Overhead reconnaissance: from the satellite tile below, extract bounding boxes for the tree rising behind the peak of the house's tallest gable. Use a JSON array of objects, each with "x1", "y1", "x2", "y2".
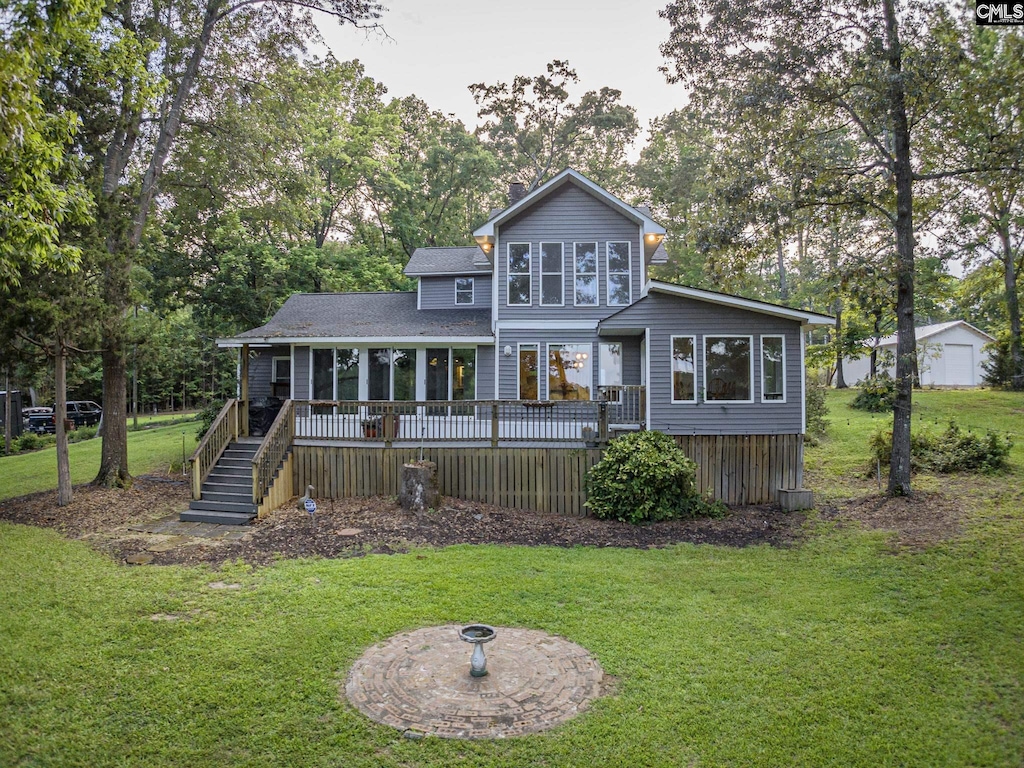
[{"x1": 469, "y1": 59, "x2": 639, "y2": 190}]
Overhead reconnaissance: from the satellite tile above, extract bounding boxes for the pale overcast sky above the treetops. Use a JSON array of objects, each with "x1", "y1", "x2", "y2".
[{"x1": 321, "y1": 0, "x2": 685, "y2": 150}]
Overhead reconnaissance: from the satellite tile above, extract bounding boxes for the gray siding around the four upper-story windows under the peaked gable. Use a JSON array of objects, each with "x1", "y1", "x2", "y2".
[{"x1": 495, "y1": 184, "x2": 643, "y2": 323}]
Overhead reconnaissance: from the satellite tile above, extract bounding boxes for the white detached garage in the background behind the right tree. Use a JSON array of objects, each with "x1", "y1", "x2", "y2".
[{"x1": 843, "y1": 321, "x2": 995, "y2": 387}]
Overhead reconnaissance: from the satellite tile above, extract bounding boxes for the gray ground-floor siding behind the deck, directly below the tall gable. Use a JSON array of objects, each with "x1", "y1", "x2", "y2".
[{"x1": 495, "y1": 329, "x2": 640, "y2": 400}]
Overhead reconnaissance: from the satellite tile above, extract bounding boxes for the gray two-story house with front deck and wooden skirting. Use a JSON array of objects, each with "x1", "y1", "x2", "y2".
[{"x1": 194, "y1": 170, "x2": 833, "y2": 528}]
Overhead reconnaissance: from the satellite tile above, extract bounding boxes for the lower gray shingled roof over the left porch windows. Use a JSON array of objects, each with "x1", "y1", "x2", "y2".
[{"x1": 217, "y1": 291, "x2": 495, "y2": 346}]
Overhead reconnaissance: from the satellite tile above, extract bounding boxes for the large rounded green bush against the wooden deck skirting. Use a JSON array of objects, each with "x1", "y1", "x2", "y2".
[{"x1": 587, "y1": 431, "x2": 724, "y2": 523}]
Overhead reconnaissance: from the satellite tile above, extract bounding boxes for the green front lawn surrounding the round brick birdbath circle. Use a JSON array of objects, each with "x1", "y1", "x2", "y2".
[{"x1": 0, "y1": 392, "x2": 1024, "y2": 768}]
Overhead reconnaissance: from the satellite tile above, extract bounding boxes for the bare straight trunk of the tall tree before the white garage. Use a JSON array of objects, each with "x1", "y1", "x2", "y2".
[{"x1": 883, "y1": 0, "x2": 918, "y2": 496}]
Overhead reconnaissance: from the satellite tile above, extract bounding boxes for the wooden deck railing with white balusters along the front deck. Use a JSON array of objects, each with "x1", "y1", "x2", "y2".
[{"x1": 295, "y1": 387, "x2": 643, "y2": 446}]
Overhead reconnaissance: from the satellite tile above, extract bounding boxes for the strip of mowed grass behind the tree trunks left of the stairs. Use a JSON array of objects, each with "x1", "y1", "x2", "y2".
[{"x1": 0, "y1": 423, "x2": 196, "y2": 500}]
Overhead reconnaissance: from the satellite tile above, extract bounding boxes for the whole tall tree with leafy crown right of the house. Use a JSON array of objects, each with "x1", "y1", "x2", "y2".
[{"x1": 662, "y1": 0, "x2": 948, "y2": 495}]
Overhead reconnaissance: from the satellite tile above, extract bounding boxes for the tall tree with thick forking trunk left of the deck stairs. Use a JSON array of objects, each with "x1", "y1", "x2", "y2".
[{"x1": 57, "y1": 0, "x2": 380, "y2": 485}]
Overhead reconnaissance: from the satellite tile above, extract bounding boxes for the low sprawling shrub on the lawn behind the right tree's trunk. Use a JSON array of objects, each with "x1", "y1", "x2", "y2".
[{"x1": 870, "y1": 422, "x2": 1014, "y2": 474}]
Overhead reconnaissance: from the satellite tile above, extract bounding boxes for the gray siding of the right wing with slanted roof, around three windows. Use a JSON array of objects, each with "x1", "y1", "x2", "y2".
[{"x1": 602, "y1": 293, "x2": 803, "y2": 434}]
